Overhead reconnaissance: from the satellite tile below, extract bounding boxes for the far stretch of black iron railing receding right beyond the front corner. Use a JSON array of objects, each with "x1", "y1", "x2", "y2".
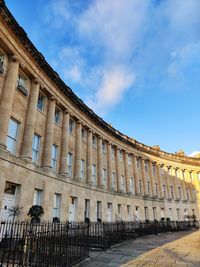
[{"x1": 89, "y1": 221, "x2": 198, "y2": 250}]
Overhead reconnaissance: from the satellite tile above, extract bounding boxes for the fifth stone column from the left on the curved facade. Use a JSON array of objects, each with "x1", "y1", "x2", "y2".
[{"x1": 74, "y1": 121, "x2": 82, "y2": 180}]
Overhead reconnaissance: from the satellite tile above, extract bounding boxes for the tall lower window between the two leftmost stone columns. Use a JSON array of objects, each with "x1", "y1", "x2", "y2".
[{"x1": 6, "y1": 119, "x2": 19, "y2": 154}]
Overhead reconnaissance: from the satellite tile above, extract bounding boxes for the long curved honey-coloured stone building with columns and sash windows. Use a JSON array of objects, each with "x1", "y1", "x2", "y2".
[{"x1": 0, "y1": 1, "x2": 200, "y2": 221}]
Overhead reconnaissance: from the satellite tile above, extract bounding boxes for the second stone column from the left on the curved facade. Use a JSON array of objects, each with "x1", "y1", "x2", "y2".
[{"x1": 21, "y1": 79, "x2": 40, "y2": 160}]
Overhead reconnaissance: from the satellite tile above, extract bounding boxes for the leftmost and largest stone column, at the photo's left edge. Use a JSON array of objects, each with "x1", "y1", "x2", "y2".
[{"x1": 0, "y1": 56, "x2": 19, "y2": 148}]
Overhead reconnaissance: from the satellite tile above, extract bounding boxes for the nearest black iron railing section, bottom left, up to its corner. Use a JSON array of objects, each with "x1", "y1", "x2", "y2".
[{"x1": 0, "y1": 222, "x2": 89, "y2": 267}]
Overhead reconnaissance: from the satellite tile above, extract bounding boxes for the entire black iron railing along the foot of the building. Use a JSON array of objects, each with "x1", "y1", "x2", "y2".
[{"x1": 0, "y1": 221, "x2": 198, "y2": 267}]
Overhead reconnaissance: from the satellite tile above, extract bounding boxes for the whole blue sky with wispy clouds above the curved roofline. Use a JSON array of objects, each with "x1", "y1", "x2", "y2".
[{"x1": 6, "y1": 0, "x2": 200, "y2": 154}]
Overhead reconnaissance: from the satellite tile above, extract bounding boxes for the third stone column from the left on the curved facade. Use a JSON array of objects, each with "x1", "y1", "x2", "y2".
[{"x1": 42, "y1": 96, "x2": 56, "y2": 168}]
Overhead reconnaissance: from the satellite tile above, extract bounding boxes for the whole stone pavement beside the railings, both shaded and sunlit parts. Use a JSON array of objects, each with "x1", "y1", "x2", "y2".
[{"x1": 79, "y1": 231, "x2": 200, "y2": 267}]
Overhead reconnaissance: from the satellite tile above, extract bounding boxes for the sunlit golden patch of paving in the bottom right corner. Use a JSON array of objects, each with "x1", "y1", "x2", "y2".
[{"x1": 123, "y1": 231, "x2": 200, "y2": 267}]
